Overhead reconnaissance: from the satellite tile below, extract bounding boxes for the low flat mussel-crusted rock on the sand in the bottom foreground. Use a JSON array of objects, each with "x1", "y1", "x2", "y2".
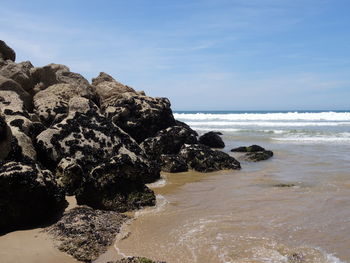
[{"x1": 47, "y1": 206, "x2": 128, "y2": 262}]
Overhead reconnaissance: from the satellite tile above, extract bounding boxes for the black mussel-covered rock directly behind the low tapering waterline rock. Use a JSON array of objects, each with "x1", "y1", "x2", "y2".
[{"x1": 140, "y1": 126, "x2": 197, "y2": 160}]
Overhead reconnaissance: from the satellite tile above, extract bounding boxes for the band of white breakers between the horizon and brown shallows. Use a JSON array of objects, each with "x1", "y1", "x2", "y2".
[{"x1": 174, "y1": 111, "x2": 350, "y2": 143}]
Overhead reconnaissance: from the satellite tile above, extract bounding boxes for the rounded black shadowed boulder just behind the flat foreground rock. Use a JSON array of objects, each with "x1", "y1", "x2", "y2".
[{"x1": 76, "y1": 151, "x2": 159, "y2": 212}]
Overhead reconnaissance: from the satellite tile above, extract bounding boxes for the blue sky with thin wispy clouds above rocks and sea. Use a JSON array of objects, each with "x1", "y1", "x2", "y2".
[{"x1": 0, "y1": 0, "x2": 350, "y2": 110}]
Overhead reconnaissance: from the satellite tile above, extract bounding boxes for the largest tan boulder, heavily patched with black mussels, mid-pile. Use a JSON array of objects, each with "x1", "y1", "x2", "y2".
[{"x1": 36, "y1": 97, "x2": 160, "y2": 194}]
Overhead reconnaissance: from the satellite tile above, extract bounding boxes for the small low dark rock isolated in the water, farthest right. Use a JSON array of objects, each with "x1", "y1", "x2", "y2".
[{"x1": 231, "y1": 144, "x2": 273, "y2": 162}]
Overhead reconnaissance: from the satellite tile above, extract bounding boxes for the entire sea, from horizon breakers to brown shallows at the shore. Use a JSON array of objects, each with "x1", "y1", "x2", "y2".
[{"x1": 97, "y1": 111, "x2": 350, "y2": 263}]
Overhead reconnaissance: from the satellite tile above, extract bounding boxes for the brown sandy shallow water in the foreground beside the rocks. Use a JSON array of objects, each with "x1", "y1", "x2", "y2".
[{"x1": 96, "y1": 143, "x2": 350, "y2": 263}]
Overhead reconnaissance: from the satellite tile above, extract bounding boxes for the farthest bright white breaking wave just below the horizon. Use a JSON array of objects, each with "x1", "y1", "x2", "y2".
[{"x1": 174, "y1": 111, "x2": 350, "y2": 121}]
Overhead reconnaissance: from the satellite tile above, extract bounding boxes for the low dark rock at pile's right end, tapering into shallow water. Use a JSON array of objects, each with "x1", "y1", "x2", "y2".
[{"x1": 180, "y1": 144, "x2": 241, "y2": 172}]
